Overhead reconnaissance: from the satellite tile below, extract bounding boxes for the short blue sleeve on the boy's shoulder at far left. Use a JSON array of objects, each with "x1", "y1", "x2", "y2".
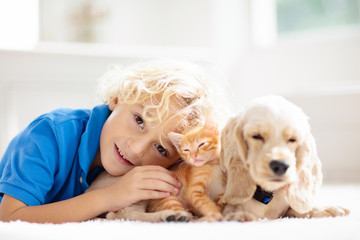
[{"x1": 0, "y1": 118, "x2": 59, "y2": 205}]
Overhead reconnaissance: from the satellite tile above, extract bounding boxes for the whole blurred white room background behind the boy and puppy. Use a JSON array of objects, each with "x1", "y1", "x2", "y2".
[{"x1": 0, "y1": 0, "x2": 360, "y2": 183}]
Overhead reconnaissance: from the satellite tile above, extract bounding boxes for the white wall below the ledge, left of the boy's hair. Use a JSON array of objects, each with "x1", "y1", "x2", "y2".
[{"x1": 0, "y1": 50, "x2": 131, "y2": 155}]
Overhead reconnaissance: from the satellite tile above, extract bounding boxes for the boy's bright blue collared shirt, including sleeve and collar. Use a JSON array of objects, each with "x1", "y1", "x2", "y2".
[{"x1": 0, "y1": 105, "x2": 111, "y2": 206}]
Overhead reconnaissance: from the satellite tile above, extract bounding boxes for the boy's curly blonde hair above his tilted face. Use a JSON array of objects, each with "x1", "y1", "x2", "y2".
[{"x1": 98, "y1": 60, "x2": 217, "y2": 138}]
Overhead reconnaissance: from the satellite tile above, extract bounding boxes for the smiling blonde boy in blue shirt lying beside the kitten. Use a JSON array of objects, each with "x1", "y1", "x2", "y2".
[{"x1": 0, "y1": 61, "x2": 211, "y2": 223}]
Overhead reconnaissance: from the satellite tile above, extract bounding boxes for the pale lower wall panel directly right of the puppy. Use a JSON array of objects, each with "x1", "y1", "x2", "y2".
[{"x1": 289, "y1": 93, "x2": 360, "y2": 182}]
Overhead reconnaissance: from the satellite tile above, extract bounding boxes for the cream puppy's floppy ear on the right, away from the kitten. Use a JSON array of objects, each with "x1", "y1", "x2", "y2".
[{"x1": 288, "y1": 131, "x2": 322, "y2": 213}]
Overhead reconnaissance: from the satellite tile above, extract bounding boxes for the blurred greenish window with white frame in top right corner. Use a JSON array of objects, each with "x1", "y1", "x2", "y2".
[{"x1": 250, "y1": 0, "x2": 360, "y2": 46}]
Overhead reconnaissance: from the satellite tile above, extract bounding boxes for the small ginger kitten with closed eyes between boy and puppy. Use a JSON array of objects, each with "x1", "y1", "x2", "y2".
[{"x1": 147, "y1": 126, "x2": 225, "y2": 221}]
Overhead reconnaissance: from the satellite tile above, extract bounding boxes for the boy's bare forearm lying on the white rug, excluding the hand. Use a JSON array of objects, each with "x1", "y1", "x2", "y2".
[{"x1": 3, "y1": 190, "x2": 108, "y2": 223}]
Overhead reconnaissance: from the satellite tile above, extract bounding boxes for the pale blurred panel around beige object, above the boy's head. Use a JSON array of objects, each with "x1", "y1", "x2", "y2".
[{"x1": 40, "y1": 0, "x2": 213, "y2": 47}]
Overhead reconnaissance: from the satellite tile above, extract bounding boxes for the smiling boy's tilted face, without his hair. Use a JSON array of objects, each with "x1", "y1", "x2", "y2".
[{"x1": 100, "y1": 104, "x2": 180, "y2": 176}]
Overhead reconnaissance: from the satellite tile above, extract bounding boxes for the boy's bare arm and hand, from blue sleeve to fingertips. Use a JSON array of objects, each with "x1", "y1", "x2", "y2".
[{"x1": 0, "y1": 166, "x2": 181, "y2": 223}]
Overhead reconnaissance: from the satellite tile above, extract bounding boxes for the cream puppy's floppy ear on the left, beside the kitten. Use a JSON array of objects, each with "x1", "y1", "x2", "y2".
[{"x1": 220, "y1": 115, "x2": 256, "y2": 205}]
